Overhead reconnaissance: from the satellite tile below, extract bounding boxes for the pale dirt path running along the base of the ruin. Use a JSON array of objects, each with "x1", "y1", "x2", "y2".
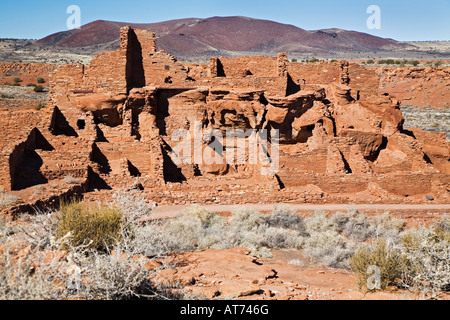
[{"x1": 153, "y1": 204, "x2": 450, "y2": 218}]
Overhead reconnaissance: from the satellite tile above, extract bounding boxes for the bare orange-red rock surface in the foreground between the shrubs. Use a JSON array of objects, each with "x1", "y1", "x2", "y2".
[{"x1": 151, "y1": 248, "x2": 450, "y2": 300}]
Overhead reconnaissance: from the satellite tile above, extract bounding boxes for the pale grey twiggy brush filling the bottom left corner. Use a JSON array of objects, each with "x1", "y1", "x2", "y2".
[{"x1": 0, "y1": 239, "x2": 171, "y2": 300}]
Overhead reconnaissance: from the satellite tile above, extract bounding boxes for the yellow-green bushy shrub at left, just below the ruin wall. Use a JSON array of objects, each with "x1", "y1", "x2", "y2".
[{"x1": 57, "y1": 201, "x2": 124, "y2": 250}]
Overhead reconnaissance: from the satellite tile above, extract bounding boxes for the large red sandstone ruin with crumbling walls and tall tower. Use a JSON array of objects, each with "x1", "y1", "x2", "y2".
[{"x1": 0, "y1": 27, "x2": 450, "y2": 211}]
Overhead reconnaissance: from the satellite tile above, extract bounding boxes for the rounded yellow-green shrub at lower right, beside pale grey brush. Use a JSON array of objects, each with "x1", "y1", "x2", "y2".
[{"x1": 350, "y1": 238, "x2": 407, "y2": 289}]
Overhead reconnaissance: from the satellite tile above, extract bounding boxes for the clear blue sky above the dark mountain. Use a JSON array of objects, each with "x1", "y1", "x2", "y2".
[{"x1": 0, "y1": 0, "x2": 450, "y2": 41}]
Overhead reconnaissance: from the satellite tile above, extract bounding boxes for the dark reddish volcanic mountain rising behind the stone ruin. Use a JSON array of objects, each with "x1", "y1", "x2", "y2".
[{"x1": 37, "y1": 17, "x2": 410, "y2": 58}]
